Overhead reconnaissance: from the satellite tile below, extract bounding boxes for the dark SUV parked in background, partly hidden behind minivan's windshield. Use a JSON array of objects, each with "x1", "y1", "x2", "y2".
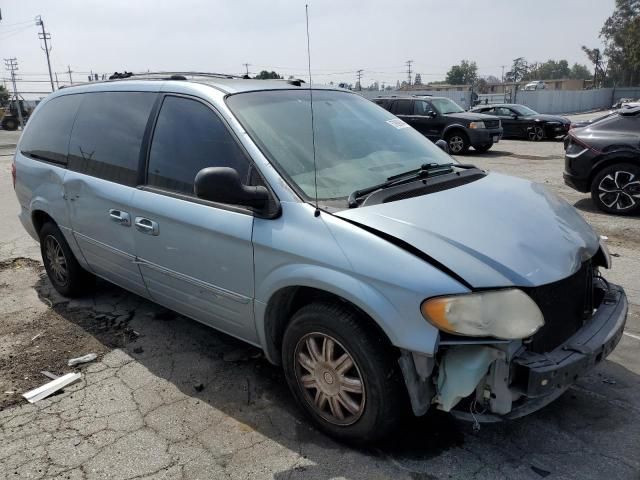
[{"x1": 373, "y1": 97, "x2": 502, "y2": 154}]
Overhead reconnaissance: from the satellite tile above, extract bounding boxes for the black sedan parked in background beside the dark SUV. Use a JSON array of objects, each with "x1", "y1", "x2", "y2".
[{"x1": 471, "y1": 103, "x2": 571, "y2": 142}]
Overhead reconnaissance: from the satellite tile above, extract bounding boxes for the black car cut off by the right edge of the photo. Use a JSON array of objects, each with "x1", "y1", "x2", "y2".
[{"x1": 563, "y1": 107, "x2": 640, "y2": 214}]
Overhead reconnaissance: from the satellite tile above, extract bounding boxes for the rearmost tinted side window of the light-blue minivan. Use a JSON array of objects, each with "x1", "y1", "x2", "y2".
[{"x1": 20, "y1": 95, "x2": 82, "y2": 165}]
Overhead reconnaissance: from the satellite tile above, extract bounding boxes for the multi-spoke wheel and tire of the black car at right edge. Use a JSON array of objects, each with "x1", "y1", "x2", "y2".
[{"x1": 591, "y1": 163, "x2": 640, "y2": 215}]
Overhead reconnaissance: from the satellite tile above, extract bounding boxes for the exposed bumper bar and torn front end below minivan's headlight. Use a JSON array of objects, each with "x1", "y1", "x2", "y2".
[{"x1": 399, "y1": 274, "x2": 628, "y2": 422}]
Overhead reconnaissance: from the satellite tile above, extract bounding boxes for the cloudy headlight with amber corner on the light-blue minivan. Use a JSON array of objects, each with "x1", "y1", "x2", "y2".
[{"x1": 420, "y1": 288, "x2": 544, "y2": 340}]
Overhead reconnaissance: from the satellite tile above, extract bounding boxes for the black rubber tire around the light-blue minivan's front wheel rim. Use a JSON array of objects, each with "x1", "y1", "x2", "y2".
[{"x1": 282, "y1": 308, "x2": 393, "y2": 443}]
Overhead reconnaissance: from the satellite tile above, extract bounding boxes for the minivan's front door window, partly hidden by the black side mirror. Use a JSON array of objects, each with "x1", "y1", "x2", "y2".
[{"x1": 147, "y1": 97, "x2": 249, "y2": 195}]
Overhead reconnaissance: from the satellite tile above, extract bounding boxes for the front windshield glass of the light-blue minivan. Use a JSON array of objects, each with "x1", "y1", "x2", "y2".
[{"x1": 227, "y1": 89, "x2": 453, "y2": 202}]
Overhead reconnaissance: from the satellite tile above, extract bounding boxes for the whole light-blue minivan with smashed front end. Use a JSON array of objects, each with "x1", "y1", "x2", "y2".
[{"x1": 13, "y1": 74, "x2": 627, "y2": 442}]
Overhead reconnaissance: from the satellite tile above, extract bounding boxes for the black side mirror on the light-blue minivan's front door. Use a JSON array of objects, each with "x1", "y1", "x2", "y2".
[{"x1": 194, "y1": 167, "x2": 269, "y2": 208}]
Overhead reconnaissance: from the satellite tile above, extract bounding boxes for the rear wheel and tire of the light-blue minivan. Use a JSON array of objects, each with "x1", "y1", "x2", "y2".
[{"x1": 40, "y1": 222, "x2": 95, "y2": 297}]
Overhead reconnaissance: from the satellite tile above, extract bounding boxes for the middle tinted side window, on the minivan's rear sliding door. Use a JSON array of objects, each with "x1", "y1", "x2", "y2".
[{"x1": 69, "y1": 92, "x2": 156, "y2": 186}]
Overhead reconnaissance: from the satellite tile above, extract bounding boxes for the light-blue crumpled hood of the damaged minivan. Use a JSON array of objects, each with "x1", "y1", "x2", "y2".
[{"x1": 336, "y1": 173, "x2": 599, "y2": 288}]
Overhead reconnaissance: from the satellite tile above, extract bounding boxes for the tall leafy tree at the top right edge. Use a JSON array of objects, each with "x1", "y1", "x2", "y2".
[{"x1": 596, "y1": 0, "x2": 640, "y2": 86}]
